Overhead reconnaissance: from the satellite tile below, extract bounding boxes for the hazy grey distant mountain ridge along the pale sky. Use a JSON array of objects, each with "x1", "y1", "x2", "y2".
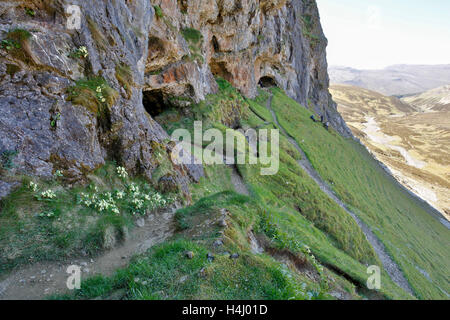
[{"x1": 328, "y1": 64, "x2": 450, "y2": 96}]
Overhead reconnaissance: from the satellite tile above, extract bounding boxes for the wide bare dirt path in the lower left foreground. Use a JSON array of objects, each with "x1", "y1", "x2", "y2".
[{"x1": 0, "y1": 208, "x2": 176, "y2": 300}]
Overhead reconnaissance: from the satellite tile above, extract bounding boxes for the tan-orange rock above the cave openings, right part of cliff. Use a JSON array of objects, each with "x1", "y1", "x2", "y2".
[{"x1": 144, "y1": 0, "x2": 350, "y2": 136}]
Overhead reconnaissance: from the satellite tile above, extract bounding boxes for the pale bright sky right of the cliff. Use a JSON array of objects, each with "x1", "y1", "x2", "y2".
[{"x1": 317, "y1": 0, "x2": 450, "y2": 69}]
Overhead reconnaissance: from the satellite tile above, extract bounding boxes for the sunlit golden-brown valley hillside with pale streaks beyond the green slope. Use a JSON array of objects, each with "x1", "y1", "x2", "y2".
[{"x1": 330, "y1": 85, "x2": 450, "y2": 219}]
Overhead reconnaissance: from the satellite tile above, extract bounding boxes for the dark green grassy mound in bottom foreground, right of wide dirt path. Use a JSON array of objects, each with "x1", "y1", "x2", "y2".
[{"x1": 53, "y1": 192, "x2": 362, "y2": 300}]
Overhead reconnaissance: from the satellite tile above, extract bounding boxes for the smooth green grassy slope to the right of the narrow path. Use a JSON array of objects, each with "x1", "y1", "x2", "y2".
[{"x1": 272, "y1": 89, "x2": 450, "y2": 299}]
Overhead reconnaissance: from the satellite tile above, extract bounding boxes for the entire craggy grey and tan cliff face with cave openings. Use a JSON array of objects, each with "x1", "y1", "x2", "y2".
[{"x1": 0, "y1": 0, "x2": 349, "y2": 199}]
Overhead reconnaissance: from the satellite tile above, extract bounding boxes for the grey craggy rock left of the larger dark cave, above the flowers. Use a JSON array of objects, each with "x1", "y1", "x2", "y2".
[{"x1": 0, "y1": 0, "x2": 202, "y2": 198}]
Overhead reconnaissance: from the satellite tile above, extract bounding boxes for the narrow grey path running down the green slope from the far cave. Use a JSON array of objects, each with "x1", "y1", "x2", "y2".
[{"x1": 267, "y1": 95, "x2": 414, "y2": 295}]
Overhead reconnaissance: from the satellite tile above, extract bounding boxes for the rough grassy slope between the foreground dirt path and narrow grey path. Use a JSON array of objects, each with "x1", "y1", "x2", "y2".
[{"x1": 59, "y1": 82, "x2": 411, "y2": 299}]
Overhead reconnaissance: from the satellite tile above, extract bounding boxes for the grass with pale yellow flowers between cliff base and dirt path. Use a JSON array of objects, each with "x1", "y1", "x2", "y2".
[{"x1": 0, "y1": 164, "x2": 173, "y2": 274}]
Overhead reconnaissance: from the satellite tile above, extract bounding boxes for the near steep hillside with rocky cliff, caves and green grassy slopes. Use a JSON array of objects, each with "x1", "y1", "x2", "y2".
[{"x1": 0, "y1": 0, "x2": 450, "y2": 300}]
